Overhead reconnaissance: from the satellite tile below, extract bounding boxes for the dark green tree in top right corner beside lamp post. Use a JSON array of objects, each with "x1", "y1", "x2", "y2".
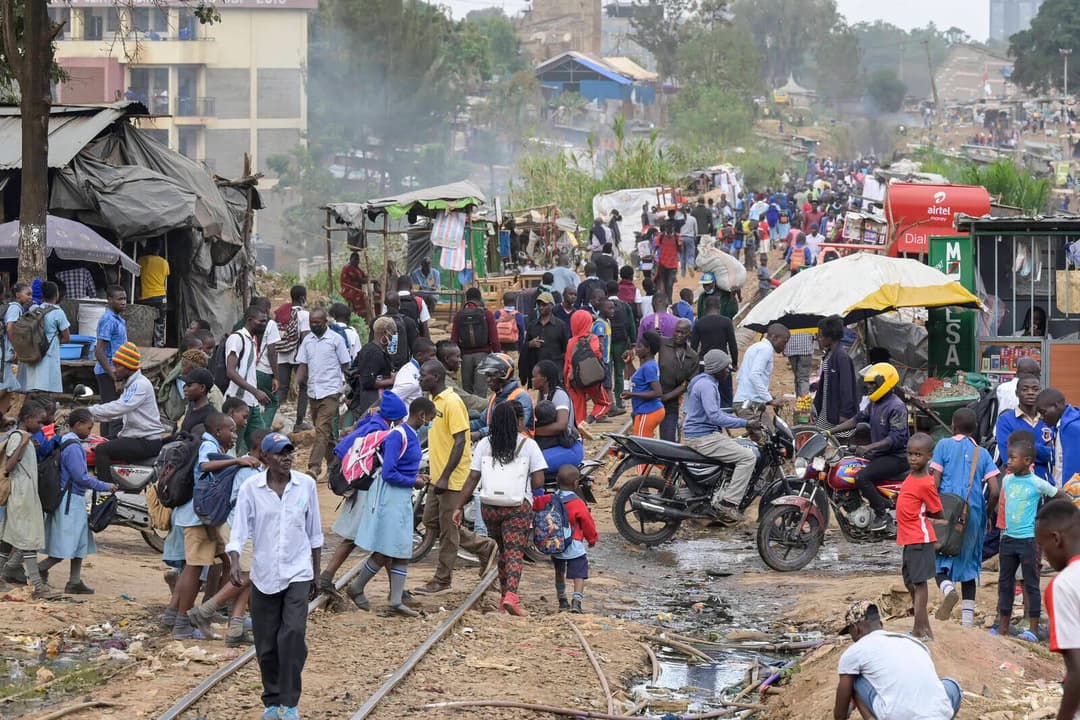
[{"x1": 1009, "y1": 0, "x2": 1080, "y2": 92}]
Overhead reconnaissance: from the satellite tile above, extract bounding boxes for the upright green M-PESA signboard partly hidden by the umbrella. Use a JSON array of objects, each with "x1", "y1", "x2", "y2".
[{"x1": 927, "y1": 235, "x2": 977, "y2": 377}]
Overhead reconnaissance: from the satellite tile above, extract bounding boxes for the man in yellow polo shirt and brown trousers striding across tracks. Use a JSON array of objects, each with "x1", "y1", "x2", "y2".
[{"x1": 414, "y1": 359, "x2": 499, "y2": 595}]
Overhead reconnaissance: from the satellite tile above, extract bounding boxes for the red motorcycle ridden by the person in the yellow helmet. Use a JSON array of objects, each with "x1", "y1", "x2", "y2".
[{"x1": 757, "y1": 433, "x2": 907, "y2": 572}]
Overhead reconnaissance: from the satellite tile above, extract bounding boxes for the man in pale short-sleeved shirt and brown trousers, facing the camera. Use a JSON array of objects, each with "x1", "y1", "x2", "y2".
[{"x1": 296, "y1": 308, "x2": 349, "y2": 477}]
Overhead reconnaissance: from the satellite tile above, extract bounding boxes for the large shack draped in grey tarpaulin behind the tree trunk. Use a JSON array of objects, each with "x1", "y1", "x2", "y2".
[{"x1": 0, "y1": 100, "x2": 261, "y2": 334}]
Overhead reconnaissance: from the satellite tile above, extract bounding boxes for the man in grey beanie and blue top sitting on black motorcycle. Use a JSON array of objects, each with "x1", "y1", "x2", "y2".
[{"x1": 683, "y1": 350, "x2": 761, "y2": 525}]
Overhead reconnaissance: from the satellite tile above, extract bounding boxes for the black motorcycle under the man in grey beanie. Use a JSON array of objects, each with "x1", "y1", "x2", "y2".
[{"x1": 608, "y1": 417, "x2": 795, "y2": 546}]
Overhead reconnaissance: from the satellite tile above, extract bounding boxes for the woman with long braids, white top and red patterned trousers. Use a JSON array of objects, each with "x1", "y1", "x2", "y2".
[{"x1": 454, "y1": 400, "x2": 548, "y2": 615}]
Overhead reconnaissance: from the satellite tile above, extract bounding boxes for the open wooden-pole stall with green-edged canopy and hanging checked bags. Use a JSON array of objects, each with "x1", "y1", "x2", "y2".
[{"x1": 325, "y1": 180, "x2": 487, "y2": 320}]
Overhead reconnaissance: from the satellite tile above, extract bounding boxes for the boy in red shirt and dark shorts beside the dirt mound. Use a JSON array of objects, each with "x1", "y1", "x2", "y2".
[{"x1": 896, "y1": 433, "x2": 942, "y2": 639}]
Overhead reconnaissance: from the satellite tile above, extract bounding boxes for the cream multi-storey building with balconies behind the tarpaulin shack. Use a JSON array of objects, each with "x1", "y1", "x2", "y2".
[{"x1": 49, "y1": 0, "x2": 319, "y2": 248}]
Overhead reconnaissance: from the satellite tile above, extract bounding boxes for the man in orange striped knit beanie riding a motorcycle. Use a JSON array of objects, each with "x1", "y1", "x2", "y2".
[{"x1": 87, "y1": 342, "x2": 164, "y2": 477}]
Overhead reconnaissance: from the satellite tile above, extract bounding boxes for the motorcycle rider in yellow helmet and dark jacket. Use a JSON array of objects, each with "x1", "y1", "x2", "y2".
[{"x1": 832, "y1": 363, "x2": 908, "y2": 532}]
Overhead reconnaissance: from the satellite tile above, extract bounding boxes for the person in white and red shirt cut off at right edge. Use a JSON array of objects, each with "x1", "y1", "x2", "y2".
[{"x1": 1035, "y1": 500, "x2": 1080, "y2": 719}]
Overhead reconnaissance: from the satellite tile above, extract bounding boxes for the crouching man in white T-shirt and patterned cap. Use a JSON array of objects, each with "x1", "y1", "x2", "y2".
[{"x1": 833, "y1": 600, "x2": 962, "y2": 720}]
